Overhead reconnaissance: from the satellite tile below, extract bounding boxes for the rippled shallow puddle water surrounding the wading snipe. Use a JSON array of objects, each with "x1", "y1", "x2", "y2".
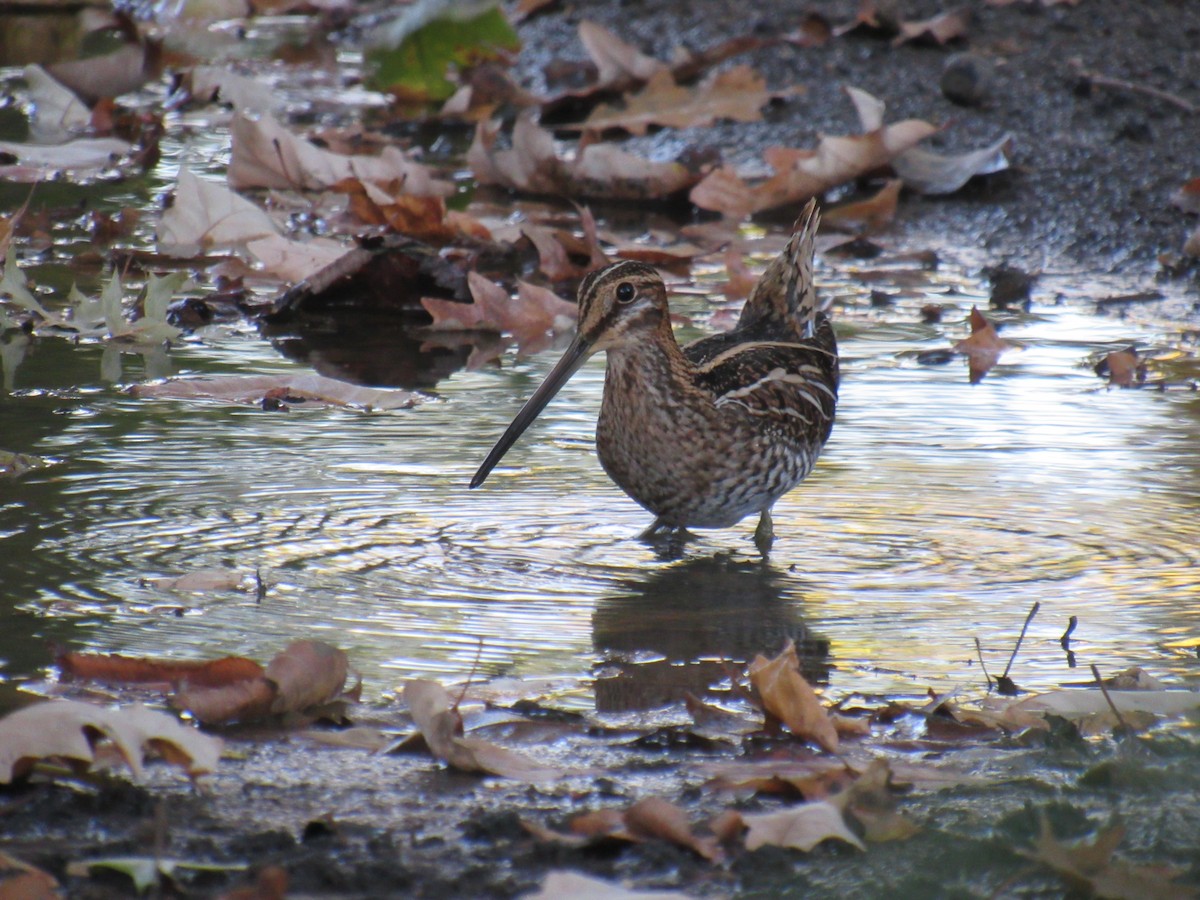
[{"x1": 0, "y1": 241, "x2": 1200, "y2": 709}]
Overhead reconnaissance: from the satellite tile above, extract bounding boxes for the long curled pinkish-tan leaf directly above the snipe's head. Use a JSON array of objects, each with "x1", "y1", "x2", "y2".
[{"x1": 467, "y1": 113, "x2": 698, "y2": 199}]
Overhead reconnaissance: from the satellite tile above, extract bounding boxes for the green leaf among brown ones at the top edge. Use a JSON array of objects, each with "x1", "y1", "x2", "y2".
[{"x1": 366, "y1": 5, "x2": 521, "y2": 101}]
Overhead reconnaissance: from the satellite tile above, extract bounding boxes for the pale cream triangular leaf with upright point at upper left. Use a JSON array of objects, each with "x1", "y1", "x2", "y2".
[{"x1": 157, "y1": 168, "x2": 278, "y2": 258}]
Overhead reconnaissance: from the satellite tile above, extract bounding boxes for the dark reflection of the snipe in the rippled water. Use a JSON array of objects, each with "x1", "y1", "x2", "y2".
[{"x1": 592, "y1": 556, "x2": 829, "y2": 713}]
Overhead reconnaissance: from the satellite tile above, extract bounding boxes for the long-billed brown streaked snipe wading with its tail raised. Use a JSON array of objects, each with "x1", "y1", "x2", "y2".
[{"x1": 470, "y1": 200, "x2": 839, "y2": 556}]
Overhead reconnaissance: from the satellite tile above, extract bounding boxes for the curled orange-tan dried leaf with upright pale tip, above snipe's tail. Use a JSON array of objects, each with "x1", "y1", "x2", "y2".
[{"x1": 689, "y1": 88, "x2": 937, "y2": 217}]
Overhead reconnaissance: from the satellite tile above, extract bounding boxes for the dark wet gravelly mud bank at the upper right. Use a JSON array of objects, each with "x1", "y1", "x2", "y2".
[{"x1": 521, "y1": 0, "x2": 1200, "y2": 287}]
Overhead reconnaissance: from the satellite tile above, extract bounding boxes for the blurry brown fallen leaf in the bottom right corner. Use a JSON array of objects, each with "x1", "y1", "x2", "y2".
[{"x1": 1016, "y1": 815, "x2": 1198, "y2": 900}]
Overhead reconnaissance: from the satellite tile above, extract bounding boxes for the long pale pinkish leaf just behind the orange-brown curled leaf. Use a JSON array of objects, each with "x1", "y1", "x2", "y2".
[{"x1": 226, "y1": 113, "x2": 454, "y2": 197}]
